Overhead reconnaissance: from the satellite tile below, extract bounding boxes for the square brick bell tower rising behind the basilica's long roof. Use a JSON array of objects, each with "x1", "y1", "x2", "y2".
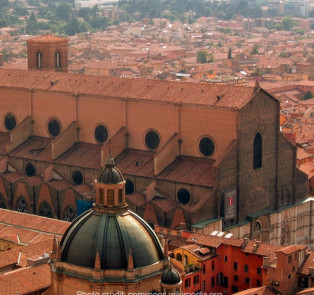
[{"x1": 27, "y1": 34, "x2": 69, "y2": 72}]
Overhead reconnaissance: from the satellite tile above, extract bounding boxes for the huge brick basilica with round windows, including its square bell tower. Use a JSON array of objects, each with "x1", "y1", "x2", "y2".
[{"x1": 0, "y1": 35, "x2": 312, "y2": 250}]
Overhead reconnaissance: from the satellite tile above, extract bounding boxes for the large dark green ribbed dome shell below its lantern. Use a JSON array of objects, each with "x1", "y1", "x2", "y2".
[{"x1": 61, "y1": 209, "x2": 164, "y2": 269}]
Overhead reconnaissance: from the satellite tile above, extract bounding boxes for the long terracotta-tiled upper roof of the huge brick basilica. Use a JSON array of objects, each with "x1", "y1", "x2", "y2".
[{"x1": 0, "y1": 69, "x2": 254, "y2": 109}]
